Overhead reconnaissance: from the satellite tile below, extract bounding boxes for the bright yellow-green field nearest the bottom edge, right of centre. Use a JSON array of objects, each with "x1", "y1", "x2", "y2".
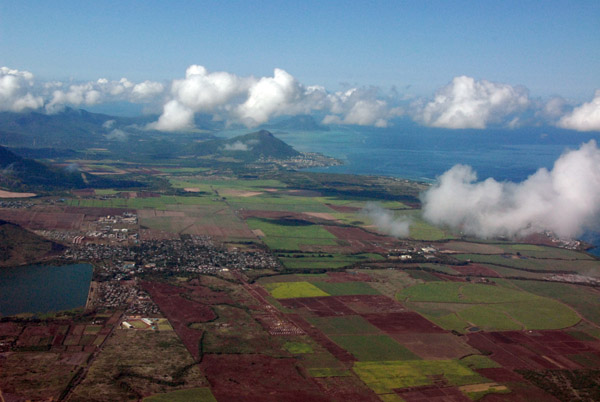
[{"x1": 353, "y1": 360, "x2": 489, "y2": 394}]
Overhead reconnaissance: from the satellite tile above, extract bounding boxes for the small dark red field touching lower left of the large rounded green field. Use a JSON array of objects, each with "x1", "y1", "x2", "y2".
[{"x1": 361, "y1": 312, "x2": 446, "y2": 334}]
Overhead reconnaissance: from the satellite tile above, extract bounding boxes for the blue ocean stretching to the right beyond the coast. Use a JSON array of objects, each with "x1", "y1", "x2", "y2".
[{"x1": 227, "y1": 123, "x2": 600, "y2": 256}]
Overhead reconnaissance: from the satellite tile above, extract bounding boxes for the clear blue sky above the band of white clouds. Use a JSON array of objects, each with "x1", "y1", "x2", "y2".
[{"x1": 0, "y1": 1, "x2": 600, "y2": 100}]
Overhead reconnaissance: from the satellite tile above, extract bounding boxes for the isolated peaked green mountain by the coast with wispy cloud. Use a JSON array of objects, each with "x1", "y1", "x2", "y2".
[{"x1": 194, "y1": 130, "x2": 300, "y2": 162}]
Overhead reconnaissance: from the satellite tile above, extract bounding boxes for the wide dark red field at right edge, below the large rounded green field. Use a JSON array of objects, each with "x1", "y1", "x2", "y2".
[{"x1": 468, "y1": 330, "x2": 600, "y2": 370}]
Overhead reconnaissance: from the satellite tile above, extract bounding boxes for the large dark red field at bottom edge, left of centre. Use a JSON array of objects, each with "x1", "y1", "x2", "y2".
[{"x1": 200, "y1": 354, "x2": 330, "y2": 402}]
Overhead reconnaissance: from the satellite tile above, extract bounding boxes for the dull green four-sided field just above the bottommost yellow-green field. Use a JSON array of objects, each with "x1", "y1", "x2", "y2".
[{"x1": 331, "y1": 335, "x2": 419, "y2": 361}]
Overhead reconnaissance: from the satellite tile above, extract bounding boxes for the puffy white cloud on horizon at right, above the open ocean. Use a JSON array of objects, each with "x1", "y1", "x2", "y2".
[{"x1": 415, "y1": 76, "x2": 530, "y2": 129}]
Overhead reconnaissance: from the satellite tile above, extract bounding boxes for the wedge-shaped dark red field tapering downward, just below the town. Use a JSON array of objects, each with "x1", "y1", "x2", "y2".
[{"x1": 142, "y1": 282, "x2": 216, "y2": 360}]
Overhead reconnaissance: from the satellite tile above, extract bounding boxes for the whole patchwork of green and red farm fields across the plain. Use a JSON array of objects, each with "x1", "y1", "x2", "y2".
[{"x1": 0, "y1": 163, "x2": 600, "y2": 402}]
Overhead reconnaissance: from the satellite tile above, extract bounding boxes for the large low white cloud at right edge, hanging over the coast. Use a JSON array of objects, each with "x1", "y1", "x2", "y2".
[{"x1": 422, "y1": 140, "x2": 600, "y2": 238}]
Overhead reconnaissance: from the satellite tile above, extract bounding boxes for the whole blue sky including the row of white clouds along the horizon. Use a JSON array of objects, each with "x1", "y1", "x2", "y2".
[{"x1": 0, "y1": 0, "x2": 600, "y2": 131}]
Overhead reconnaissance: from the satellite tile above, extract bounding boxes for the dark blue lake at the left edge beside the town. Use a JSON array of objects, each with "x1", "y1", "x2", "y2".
[{"x1": 0, "y1": 264, "x2": 93, "y2": 316}]
